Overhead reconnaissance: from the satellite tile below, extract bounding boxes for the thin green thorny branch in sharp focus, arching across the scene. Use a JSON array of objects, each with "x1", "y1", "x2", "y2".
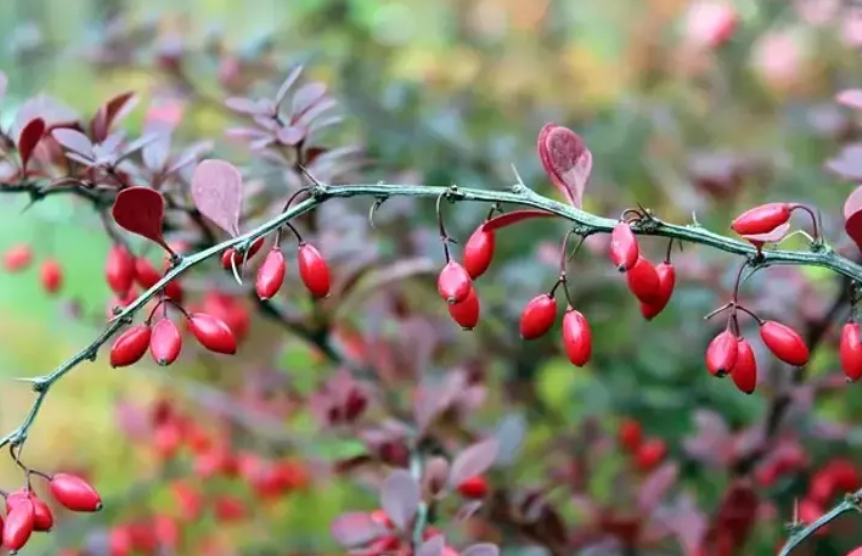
[{"x1": 0, "y1": 180, "x2": 862, "y2": 458}]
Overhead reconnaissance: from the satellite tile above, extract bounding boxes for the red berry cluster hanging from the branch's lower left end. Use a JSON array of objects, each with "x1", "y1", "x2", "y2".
[{"x1": 0, "y1": 472, "x2": 102, "y2": 554}]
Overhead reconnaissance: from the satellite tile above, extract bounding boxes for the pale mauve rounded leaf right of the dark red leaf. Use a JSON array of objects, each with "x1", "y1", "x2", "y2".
[{"x1": 192, "y1": 159, "x2": 242, "y2": 236}]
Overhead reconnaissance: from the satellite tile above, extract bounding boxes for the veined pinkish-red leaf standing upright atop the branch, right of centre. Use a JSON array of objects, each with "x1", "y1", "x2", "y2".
[{"x1": 536, "y1": 124, "x2": 593, "y2": 208}]
